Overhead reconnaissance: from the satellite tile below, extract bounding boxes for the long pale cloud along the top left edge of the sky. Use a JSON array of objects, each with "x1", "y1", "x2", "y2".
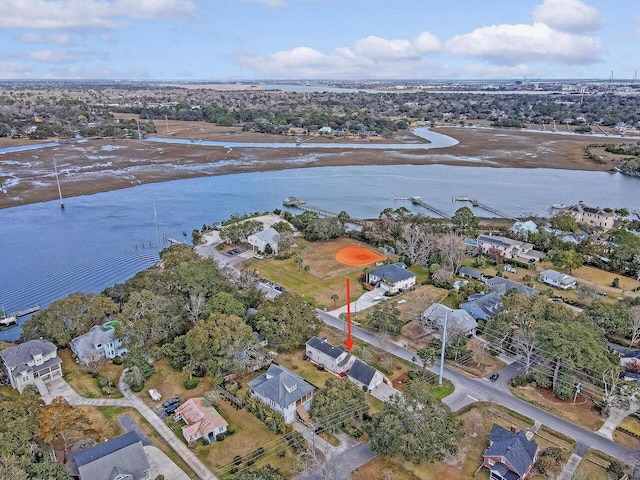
[{"x1": 0, "y1": 0, "x2": 195, "y2": 30}]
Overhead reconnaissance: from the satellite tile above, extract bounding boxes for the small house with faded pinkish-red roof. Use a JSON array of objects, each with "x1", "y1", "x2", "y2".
[{"x1": 174, "y1": 397, "x2": 229, "y2": 443}]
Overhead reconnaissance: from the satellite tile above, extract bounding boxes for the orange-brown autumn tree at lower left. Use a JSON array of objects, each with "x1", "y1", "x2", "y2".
[{"x1": 36, "y1": 397, "x2": 96, "y2": 457}]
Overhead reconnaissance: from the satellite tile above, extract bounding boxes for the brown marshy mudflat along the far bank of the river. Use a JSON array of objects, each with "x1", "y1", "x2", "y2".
[{"x1": 0, "y1": 121, "x2": 628, "y2": 208}]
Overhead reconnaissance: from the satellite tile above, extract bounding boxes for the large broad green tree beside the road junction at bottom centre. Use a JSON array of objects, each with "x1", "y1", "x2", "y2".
[{"x1": 365, "y1": 381, "x2": 462, "y2": 463}]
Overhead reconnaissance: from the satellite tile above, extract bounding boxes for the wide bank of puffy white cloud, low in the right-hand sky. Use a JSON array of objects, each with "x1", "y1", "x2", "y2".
[{"x1": 446, "y1": 23, "x2": 604, "y2": 65}]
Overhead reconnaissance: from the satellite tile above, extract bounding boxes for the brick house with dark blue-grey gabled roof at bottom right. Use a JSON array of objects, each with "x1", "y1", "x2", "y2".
[{"x1": 482, "y1": 424, "x2": 540, "y2": 480}]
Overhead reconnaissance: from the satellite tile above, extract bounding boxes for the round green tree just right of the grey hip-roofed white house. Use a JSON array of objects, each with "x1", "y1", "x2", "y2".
[{"x1": 310, "y1": 378, "x2": 368, "y2": 432}]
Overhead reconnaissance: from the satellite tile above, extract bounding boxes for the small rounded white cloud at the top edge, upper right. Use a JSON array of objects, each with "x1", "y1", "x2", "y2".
[{"x1": 533, "y1": 0, "x2": 601, "y2": 33}]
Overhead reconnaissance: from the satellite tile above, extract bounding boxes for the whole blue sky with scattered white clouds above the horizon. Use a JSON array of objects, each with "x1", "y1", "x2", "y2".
[{"x1": 0, "y1": 0, "x2": 640, "y2": 81}]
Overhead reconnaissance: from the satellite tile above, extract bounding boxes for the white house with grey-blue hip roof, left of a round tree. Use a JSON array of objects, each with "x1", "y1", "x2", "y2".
[{"x1": 247, "y1": 364, "x2": 314, "y2": 423}]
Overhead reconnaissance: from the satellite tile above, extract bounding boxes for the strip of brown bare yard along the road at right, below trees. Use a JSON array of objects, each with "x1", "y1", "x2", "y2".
[{"x1": 509, "y1": 386, "x2": 605, "y2": 431}]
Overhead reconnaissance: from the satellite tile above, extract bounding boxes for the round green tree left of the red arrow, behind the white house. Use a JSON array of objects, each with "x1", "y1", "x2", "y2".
[{"x1": 252, "y1": 293, "x2": 318, "y2": 350}]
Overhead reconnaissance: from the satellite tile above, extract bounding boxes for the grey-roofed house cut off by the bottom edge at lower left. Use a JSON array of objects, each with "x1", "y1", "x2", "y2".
[{"x1": 72, "y1": 431, "x2": 151, "y2": 480}]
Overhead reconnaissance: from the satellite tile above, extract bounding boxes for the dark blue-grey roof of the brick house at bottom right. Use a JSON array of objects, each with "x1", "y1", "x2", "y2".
[{"x1": 482, "y1": 423, "x2": 538, "y2": 477}]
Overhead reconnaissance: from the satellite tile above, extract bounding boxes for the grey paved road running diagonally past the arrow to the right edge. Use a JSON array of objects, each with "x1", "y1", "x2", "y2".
[{"x1": 316, "y1": 310, "x2": 640, "y2": 466}]
